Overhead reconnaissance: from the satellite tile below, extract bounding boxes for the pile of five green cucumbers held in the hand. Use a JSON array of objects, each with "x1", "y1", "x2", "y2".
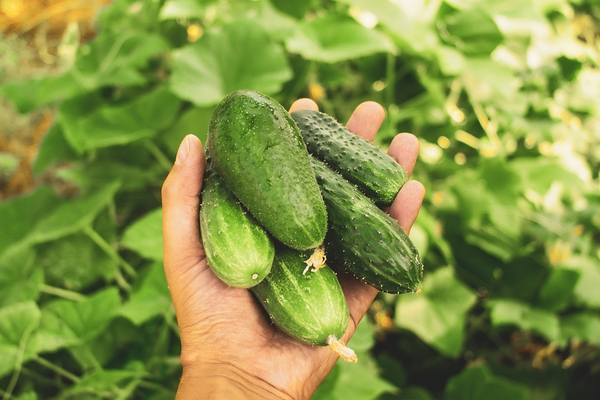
[{"x1": 200, "y1": 90, "x2": 423, "y2": 361}]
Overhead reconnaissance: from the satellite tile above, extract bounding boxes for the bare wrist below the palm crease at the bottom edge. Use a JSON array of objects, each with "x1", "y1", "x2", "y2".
[{"x1": 176, "y1": 363, "x2": 292, "y2": 400}]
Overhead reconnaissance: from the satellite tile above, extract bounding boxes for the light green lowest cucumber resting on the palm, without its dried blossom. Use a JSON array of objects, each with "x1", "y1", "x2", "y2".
[{"x1": 250, "y1": 245, "x2": 350, "y2": 346}]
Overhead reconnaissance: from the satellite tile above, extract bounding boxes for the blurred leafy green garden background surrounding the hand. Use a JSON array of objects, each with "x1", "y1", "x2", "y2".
[{"x1": 0, "y1": 0, "x2": 600, "y2": 400}]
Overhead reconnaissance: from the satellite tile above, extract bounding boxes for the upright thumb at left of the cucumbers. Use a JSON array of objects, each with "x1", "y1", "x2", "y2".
[{"x1": 161, "y1": 135, "x2": 206, "y2": 279}]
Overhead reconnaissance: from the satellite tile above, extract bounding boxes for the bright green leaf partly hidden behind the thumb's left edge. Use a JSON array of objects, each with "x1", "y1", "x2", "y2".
[{"x1": 121, "y1": 208, "x2": 163, "y2": 261}]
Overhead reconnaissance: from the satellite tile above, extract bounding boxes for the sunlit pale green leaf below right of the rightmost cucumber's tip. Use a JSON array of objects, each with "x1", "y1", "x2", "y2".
[{"x1": 394, "y1": 267, "x2": 477, "y2": 357}]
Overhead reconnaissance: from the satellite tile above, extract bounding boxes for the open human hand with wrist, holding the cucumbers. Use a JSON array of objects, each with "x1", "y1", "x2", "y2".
[{"x1": 162, "y1": 99, "x2": 425, "y2": 399}]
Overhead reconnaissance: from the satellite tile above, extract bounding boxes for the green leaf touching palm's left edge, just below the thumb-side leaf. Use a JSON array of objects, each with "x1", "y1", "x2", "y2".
[{"x1": 118, "y1": 262, "x2": 172, "y2": 326}]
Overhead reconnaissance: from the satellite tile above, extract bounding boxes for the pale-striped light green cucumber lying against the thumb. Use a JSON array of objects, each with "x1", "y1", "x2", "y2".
[{"x1": 199, "y1": 168, "x2": 275, "y2": 288}]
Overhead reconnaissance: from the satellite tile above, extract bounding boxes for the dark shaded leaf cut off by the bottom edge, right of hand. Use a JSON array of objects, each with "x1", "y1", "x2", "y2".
[{"x1": 444, "y1": 366, "x2": 528, "y2": 400}]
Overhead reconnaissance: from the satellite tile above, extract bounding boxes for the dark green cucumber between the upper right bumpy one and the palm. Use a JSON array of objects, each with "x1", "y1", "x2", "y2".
[{"x1": 312, "y1": 158, "x2": 423, "y2": 294}]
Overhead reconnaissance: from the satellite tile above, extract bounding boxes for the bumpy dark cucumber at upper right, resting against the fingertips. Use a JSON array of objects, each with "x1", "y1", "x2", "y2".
[{"x1": 291, "y1": 110, "x2": 408, "y2": 207}]
